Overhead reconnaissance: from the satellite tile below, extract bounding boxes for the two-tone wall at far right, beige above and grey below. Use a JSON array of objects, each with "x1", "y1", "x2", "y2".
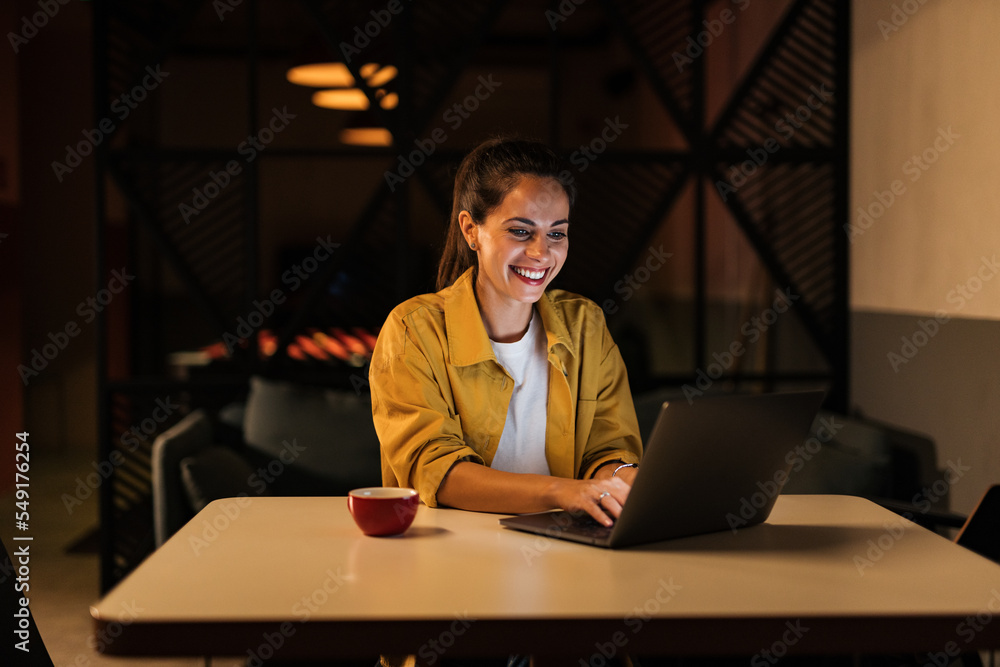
[{"x1": 845, "y1": 0, "x2": 1000, "y2": 512}]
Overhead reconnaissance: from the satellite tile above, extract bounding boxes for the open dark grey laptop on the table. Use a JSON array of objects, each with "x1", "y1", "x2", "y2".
[{"x1": 500, "y1": 391, "x2": 825, "y2": 549}]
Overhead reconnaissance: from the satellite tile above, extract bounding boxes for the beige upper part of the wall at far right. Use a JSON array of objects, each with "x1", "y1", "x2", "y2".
[{"x1": 851, "y1": 0, "x2": 1000, "y2": 319}]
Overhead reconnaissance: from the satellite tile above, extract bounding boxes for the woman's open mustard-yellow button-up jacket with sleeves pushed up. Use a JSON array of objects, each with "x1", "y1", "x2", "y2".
[{"x1": 369, "y1": 269, "x2": 642, "y2": 507}]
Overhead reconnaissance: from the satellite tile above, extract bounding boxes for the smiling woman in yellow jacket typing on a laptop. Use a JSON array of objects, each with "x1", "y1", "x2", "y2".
[{"x1": 370, "y1": 139, "x2": 642, "y2": 525}]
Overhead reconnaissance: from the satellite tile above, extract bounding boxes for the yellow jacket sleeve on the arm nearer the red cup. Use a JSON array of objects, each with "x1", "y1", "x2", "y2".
[{"x1": 369, "y1": 313, "x2": 484, "y2": 507}]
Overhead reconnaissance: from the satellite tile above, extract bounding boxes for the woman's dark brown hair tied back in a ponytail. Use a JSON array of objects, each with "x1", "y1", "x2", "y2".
[{"x1": 437, "y1": 137, "x2": 576, "y2": 290}]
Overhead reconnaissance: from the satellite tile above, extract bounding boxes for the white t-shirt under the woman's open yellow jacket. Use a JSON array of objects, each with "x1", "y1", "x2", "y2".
[{"x1": 490, "y1": 310, "x2": 549, "y2": 475}]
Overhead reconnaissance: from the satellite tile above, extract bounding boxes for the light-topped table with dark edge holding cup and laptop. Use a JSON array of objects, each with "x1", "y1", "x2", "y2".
[{"x1": 91, "y1": 495, "x2": 1000, "y2": 664}]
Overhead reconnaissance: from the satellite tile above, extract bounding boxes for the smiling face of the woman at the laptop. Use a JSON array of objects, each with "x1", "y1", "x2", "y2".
[{"x1": 459, "y1": 176, "x2": 569, "y2": 304}]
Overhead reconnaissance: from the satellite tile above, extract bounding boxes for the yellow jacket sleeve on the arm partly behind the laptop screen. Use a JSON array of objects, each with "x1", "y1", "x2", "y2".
[{"x1": 580, "y1": 313, "x2": 642, "y2": 479}]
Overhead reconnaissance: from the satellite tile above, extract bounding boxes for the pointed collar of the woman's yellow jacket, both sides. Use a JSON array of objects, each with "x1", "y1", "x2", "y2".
[{"x1": 441, "y1": 267, "x2": 576, "y2": 366}]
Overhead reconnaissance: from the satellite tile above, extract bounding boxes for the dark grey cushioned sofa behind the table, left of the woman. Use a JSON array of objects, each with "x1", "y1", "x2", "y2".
[{"x1": 152, "y1": 376, "x2": 381, "y2": 547}]
